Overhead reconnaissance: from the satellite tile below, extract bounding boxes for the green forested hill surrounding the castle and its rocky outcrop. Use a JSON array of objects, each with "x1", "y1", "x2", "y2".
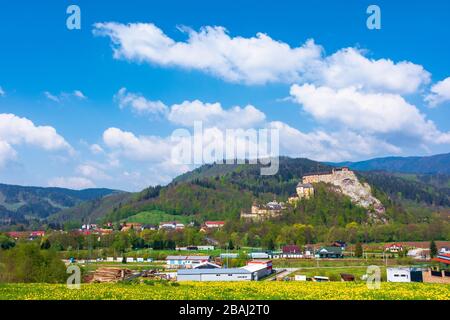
[{"x1": 98, "y1": 157, "x2": 450, "y2": 223}]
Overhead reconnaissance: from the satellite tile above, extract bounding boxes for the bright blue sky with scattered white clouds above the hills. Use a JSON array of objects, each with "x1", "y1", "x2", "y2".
[{"x1": 0, "y1": 0, "x2": 450, "y2": 190}]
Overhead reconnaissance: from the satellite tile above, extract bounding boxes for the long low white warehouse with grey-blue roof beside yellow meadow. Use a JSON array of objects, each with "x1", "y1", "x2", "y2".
[{"x1": 177, "y1": 260, "x2": 272, "y2": 281}]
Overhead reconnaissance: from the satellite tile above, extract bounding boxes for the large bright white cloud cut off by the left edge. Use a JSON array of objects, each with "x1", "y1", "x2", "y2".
[{"x1": 0, "y1": 113, "x2": 73, "y2": 164}]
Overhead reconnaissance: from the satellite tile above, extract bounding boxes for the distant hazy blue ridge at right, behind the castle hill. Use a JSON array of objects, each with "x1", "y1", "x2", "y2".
[{"x1": 333, "y1": 153, "x2": 450, "y2": 175}]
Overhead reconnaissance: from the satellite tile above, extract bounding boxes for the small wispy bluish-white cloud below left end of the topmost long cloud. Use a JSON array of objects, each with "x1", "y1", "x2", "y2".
[{"x1": 114, "y1": 88, "x2": 167, "y2": 114}]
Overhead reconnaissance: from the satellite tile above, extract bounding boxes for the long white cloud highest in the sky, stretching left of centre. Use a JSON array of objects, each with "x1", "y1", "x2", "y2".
[{"x1": 94, "y1": 22, "x2": 322, "y2": 84}]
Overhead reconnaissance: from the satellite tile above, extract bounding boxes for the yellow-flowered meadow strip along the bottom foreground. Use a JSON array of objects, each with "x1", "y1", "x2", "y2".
[{"x1": 0, "y1": 281, "x2": 450, "y2": 300}]
